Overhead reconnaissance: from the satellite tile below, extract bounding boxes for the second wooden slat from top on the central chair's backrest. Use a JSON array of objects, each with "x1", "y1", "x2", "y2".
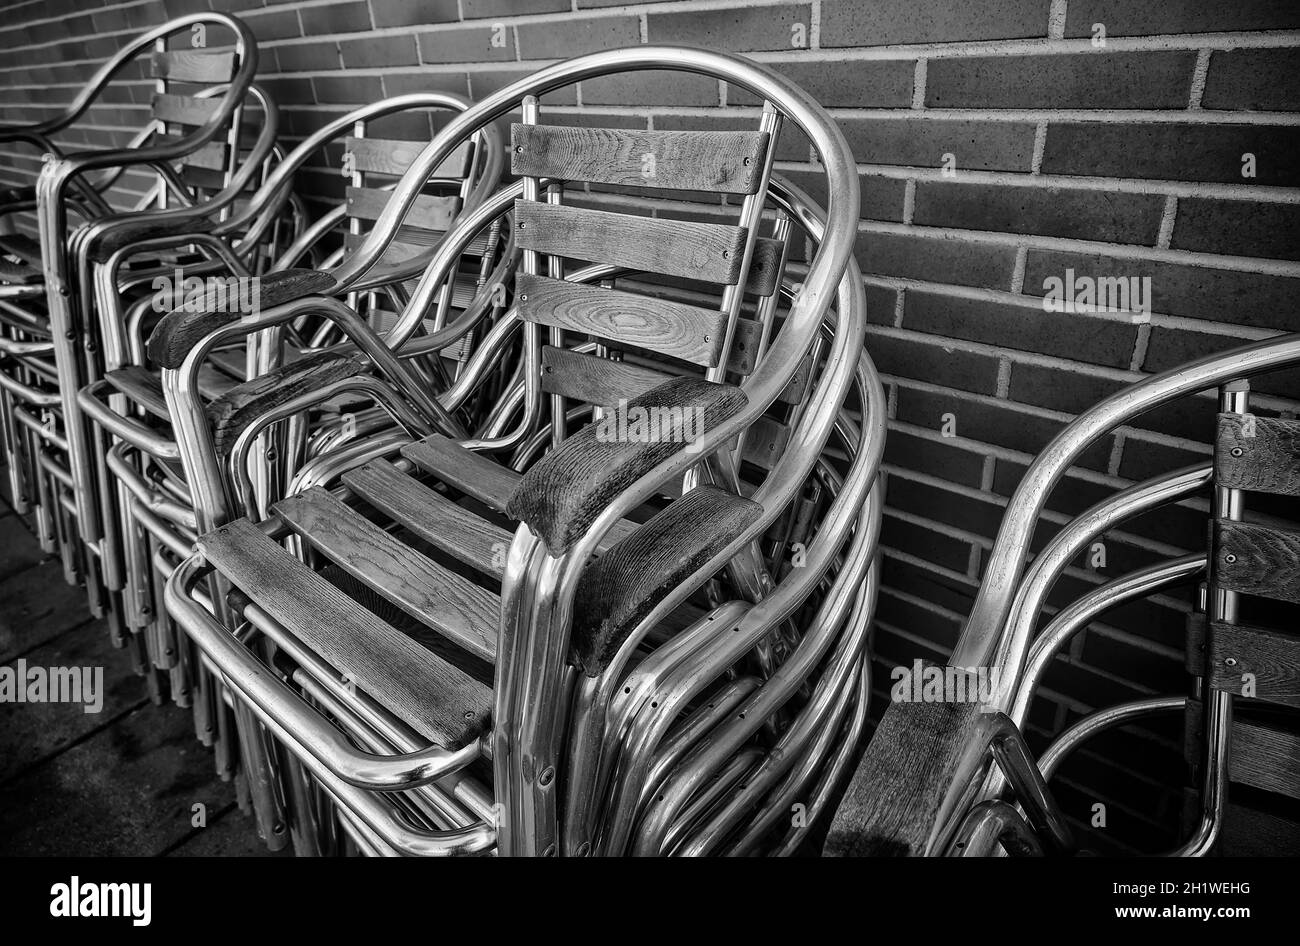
[{"x1": 515, "y1": 200, "x2": 745, "y2": 286}]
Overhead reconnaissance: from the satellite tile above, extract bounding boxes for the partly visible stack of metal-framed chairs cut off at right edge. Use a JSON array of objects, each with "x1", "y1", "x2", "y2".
[{"x1": 827, "y1": 335, "x2": 1300, "y2": 856}]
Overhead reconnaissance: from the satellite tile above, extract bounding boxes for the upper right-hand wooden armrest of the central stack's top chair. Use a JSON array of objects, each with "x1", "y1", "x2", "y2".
[{"x1": 506, "y1": 377, "x2": 749, "y2": 555}]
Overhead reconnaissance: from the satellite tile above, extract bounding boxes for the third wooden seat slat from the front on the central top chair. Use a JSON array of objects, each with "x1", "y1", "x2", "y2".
[{"x1": 343, "y1": 460, "x2": 512, "y2": 578}]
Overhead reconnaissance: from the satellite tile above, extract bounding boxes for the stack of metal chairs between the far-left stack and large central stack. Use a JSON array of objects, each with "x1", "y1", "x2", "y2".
[{"x1": 69, "y1": 92, "x2": 504, "y2": 838}]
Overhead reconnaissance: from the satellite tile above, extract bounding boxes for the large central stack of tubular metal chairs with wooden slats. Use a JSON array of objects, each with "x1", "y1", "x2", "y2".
[{"x1": 154, "y1": 47, "x2": 885, "y2": 855}]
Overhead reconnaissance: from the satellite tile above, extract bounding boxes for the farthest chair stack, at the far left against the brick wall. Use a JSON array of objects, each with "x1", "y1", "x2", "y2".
[{"x1": 0, "y1": 13, "x2": 261, "y2": 636}]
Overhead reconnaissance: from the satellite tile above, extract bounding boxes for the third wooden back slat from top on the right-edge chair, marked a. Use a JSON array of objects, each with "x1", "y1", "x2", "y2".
[{"x1": 1209, "y1": 621, "x2": 1300, "y2": 707}]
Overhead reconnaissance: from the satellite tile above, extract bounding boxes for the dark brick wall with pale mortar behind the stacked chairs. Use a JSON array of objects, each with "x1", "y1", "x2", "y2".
[{"x1": 0, "y1": 0, "x2": 1300, "y2": 851}]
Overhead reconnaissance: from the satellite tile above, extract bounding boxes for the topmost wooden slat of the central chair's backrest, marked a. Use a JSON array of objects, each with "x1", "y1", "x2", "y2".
[{"x1": 510, "y1": 123, "x2": 767, "y2": 194}]
